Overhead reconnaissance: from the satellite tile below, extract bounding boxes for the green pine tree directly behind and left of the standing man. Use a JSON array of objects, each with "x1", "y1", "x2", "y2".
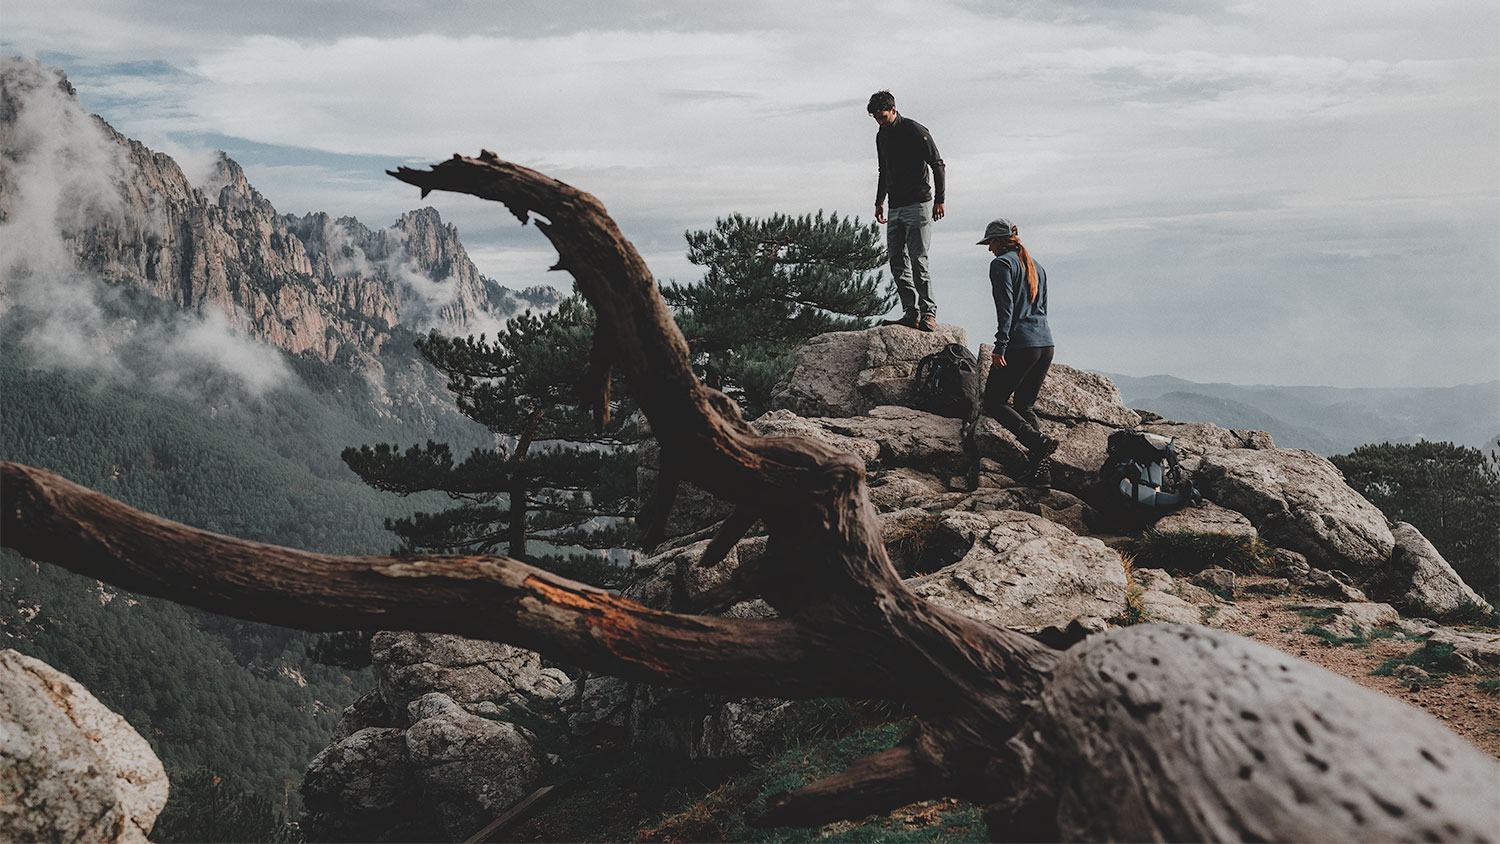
[{"x1": 662, "y1": 211, "x2": 894, "y2": 418}]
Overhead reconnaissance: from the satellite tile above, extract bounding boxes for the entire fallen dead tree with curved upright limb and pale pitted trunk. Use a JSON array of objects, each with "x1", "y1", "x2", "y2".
[{"x1": 0, "y1": 153, "x2": 1500, "y2": 841}]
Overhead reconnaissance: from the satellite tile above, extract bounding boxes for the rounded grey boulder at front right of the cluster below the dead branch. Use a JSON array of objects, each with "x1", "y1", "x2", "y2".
[{"x1": 405, "y1": 693, "x2": 545, "y2": 841}]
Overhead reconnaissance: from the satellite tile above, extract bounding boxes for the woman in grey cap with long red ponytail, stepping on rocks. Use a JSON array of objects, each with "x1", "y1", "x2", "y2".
[{"x1": 980, "y1": 217, "x2": 1058, "y2": 480}]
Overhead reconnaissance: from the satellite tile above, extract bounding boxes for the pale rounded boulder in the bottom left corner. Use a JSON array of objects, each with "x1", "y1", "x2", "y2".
[{"x1": 0, "y1": 649, "x2": 168, "y2": 843}]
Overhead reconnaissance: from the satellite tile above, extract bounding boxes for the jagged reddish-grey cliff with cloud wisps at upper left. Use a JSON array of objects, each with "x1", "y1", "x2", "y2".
[{"x1": 0, "y1": 57, "x2": 560, "y2": 381}]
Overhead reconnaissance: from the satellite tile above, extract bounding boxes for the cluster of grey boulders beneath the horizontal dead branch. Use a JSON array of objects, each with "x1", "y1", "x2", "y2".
[{"x1": 302, "y1": 633, "x2": 569, "y2": 841}]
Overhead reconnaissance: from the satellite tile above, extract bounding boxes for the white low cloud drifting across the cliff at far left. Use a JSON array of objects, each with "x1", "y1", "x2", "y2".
[{"x1": 0, "y1": 57, "x2": 291, "y2": 396}]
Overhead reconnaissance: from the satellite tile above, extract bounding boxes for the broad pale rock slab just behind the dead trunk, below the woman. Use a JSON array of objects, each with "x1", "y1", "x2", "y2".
[{"x1": 908, "y1": 510, "x2": 1125, "y2": 630}]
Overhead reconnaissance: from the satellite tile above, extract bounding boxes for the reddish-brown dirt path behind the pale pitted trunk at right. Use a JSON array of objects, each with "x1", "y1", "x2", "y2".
[{"x1": 1224, "y1": 579, "x2": 1500, "y2": 759}]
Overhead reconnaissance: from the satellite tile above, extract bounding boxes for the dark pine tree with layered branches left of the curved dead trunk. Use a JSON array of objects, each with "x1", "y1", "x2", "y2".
[{"x1": 344, "y1": 297, "x2": 636, "y2": 578}]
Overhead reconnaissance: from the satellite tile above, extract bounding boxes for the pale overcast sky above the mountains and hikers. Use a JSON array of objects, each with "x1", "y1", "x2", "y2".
[{"x1": 0, "y1": 0, "x2": 1500, "y2": 387}]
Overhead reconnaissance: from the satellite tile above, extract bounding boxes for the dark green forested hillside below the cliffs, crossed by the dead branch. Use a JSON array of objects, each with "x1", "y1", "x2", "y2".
[{"x1": 0, "y1": 325, "x2": 501, "y2": 817}]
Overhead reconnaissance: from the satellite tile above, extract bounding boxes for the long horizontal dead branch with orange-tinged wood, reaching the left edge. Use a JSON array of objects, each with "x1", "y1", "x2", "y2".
[{"x1": 0, "y1": 463, "x2": 881, "y2": 697}]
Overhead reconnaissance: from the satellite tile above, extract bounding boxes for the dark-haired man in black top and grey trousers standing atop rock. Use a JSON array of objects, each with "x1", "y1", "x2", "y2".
[{"x1": 866, "y1": 91, "x2": 945, "y2": 331}]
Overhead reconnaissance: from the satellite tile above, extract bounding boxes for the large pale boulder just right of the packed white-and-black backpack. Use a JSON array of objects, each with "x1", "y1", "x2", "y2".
[{"x1": 1196, "y1": 448, "x2": 1395, "y2": 580}]
